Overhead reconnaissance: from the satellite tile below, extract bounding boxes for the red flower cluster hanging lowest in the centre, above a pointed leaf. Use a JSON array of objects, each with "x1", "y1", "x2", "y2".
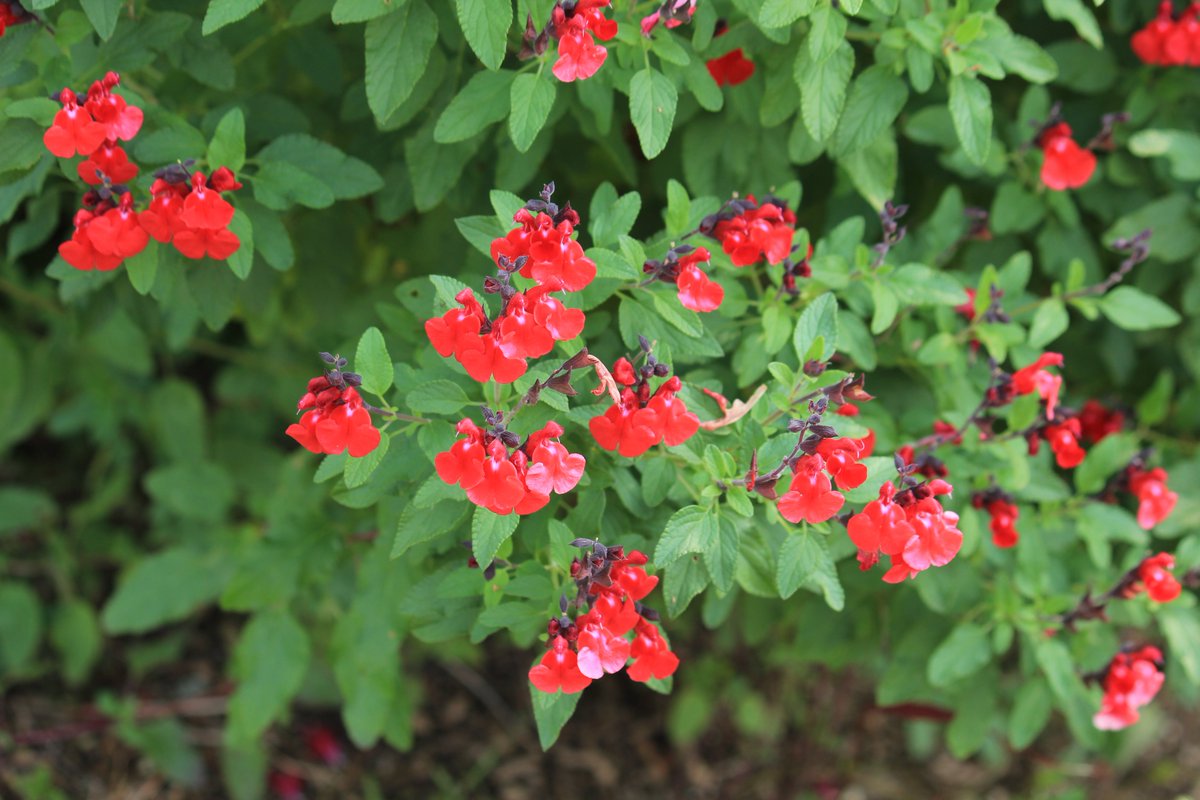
[{"x1": 529, "y1": 539, "x2": 679, "y2": 694}]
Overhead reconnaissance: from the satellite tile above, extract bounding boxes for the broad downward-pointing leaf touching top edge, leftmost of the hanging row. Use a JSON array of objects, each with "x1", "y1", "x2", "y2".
[{"x1": 366, "y1": 0, "x2": 438, "y2": 124}]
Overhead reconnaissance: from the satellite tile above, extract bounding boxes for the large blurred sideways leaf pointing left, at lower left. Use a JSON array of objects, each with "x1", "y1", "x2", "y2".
[{"x1": 101, "y1": 547, "x2": 229, "y2": 633}]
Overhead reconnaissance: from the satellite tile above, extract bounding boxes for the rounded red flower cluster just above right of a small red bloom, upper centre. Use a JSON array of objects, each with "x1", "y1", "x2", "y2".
[{"x1": 700, "y1": 194, "x2": 796, "y2": 266}]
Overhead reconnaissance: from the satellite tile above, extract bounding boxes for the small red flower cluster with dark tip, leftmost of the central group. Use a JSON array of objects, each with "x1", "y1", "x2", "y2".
[{"x1": 286, "y1": 353, "x2": 380, "y2": 458}]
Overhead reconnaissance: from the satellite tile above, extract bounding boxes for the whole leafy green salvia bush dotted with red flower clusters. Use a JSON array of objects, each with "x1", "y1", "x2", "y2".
[{"x1": 0, "y1": 0, "x2": 1200, "y2": 798}]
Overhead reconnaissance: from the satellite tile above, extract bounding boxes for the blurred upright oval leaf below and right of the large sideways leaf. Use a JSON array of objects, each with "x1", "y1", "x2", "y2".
[{"x1": 226, "y1": 610, "x2": 310, "y2": 745}]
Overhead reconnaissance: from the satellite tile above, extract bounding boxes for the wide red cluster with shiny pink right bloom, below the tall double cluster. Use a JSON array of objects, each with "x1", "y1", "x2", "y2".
[{"x1": 433, "y1": 408, "x2": 587, "y2": 515}]
